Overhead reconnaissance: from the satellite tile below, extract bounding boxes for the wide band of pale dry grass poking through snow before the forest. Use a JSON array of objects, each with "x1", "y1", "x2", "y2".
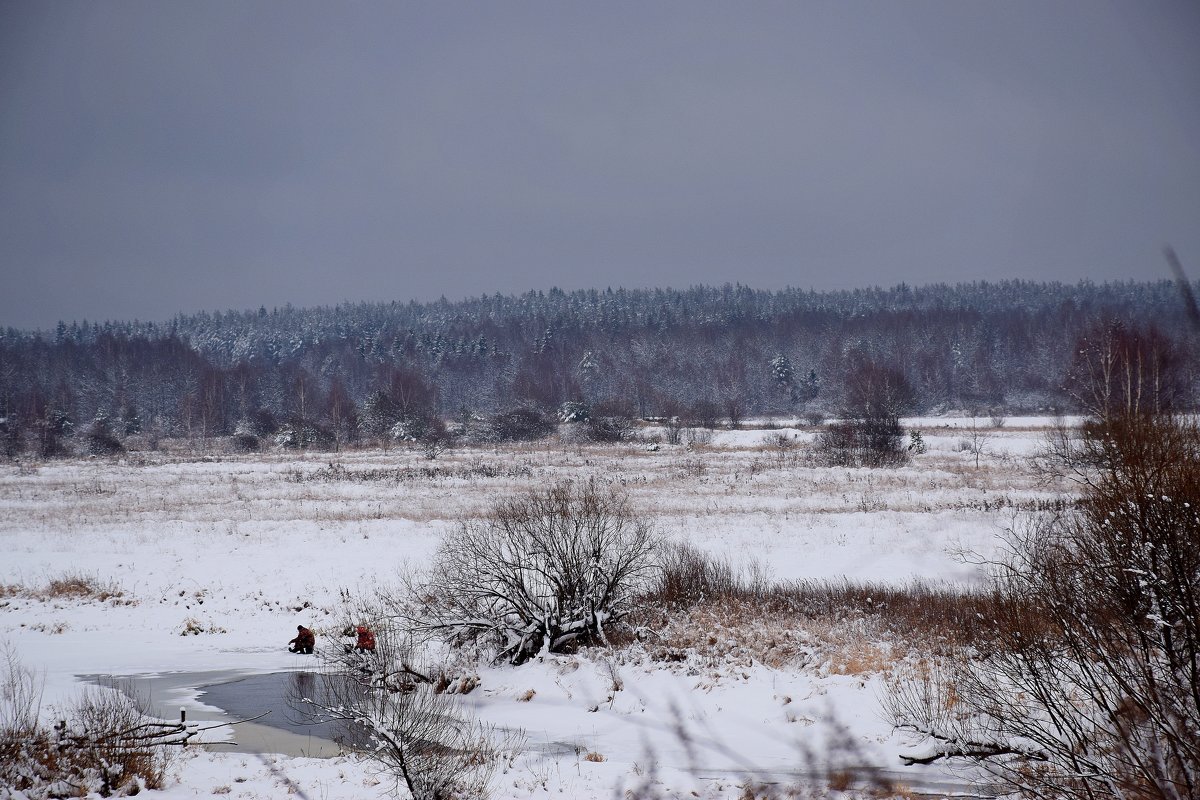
[{"x1": 0, "y1": 431, "x2": 1060, "y2": 536}]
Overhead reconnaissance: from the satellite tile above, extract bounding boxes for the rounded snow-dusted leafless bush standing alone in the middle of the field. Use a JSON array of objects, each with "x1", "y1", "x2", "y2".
[{"x1": 415, "y1": 482, "x2": 660, "y2": 663}]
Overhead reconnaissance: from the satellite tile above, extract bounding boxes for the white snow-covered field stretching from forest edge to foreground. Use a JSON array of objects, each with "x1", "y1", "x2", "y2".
[{"x1": 0, "y1": 417, "x2": 1064, "y2": 799}]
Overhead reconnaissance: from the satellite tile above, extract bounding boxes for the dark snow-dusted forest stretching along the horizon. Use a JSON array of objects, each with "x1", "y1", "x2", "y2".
[{"x1": 0, "y1": 281, "x2": 1200, "y2": 457}]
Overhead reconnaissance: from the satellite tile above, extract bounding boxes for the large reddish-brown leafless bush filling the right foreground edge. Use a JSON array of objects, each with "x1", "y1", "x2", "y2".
[{"x1": 895, "y1": 412, "x2": 1200, "y2": 800}]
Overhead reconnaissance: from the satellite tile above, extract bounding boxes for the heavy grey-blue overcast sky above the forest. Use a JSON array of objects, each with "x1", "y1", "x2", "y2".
[{"x1": 0, "y1": 0, "x2": 1200, "y2": 327}]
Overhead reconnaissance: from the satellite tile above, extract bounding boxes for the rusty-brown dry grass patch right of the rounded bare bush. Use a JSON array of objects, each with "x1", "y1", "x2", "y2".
[{"x1": 628, "y1": 545, "x2": 1015, "y2": 675}]
